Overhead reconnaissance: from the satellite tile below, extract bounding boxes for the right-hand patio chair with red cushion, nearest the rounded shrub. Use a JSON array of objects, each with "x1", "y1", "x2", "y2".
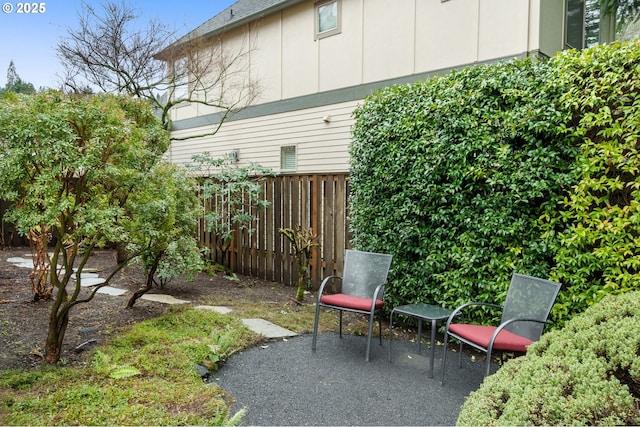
[{"x1": 442, "y1": 273, "x2": 560, "y2": 384}]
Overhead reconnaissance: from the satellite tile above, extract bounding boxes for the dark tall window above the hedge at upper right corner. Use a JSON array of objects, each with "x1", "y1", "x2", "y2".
[{"x1": 565, "y1": 0, "x2": 615, "y2": 49}]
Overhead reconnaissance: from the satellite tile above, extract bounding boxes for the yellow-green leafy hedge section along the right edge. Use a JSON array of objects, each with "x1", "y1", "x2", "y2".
[{"x1": 550, "y1": 41, "x2": 640, "y2": 324}]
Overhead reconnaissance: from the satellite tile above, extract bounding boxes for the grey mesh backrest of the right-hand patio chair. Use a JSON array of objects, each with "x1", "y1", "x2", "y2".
[{"x1": 502, "y1": 273, "x2": 560, "y2": 341}]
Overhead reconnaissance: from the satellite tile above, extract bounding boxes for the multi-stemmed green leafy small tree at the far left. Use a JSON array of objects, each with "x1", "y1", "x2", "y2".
[{"x1": 0, "y1": 91, "x2": 168, "y2": 363}]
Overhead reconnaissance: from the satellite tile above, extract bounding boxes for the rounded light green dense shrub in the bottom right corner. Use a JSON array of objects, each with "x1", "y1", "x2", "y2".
[{"x1": 458, "y1": 291, "x2": 640, "y2": 425}]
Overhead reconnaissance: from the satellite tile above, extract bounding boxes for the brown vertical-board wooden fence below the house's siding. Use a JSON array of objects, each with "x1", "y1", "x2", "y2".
[{"x1": 198, "y1": 174, "x2": 351, "y2": 289}]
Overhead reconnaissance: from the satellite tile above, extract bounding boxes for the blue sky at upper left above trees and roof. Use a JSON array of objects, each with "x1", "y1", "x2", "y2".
[{"x1": 0, "y1": 0, "x2": 236, "y2": 89}]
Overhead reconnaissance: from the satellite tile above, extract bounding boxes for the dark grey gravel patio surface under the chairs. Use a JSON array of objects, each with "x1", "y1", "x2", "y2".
[{"x1": 213, "y1": 333, "x2": 484, "y2": 426}]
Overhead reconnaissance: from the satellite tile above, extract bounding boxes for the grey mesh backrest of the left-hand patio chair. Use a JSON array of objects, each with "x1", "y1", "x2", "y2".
[{"x1": 341, "y1": 249, "x2": 392, "y2": 298}]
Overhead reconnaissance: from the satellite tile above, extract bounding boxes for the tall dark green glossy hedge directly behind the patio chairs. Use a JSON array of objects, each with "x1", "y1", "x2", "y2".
[{"x1": 350, "y1": 60, "x2": 576, "y2": 318}]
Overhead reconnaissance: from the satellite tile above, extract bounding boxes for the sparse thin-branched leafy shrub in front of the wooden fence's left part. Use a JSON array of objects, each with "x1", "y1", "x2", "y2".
[{"x1": 192, "y1": 152, "x2": 273, "y2": 270}]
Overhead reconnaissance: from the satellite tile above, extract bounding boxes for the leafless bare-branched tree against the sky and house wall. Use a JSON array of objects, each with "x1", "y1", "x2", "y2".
[{"x1": 57, "y1": 0, "x2": 258, "y2": 139}]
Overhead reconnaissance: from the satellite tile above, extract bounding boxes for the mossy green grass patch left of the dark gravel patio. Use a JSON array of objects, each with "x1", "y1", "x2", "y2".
[{"x1": 0, "y1": 307, "x2": 260, "y2": 425}]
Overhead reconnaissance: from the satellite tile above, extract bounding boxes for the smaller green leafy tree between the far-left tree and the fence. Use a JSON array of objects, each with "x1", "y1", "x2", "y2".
[{"x1": 126, "y1": 162, "x2": 202, "y2": 307}]
